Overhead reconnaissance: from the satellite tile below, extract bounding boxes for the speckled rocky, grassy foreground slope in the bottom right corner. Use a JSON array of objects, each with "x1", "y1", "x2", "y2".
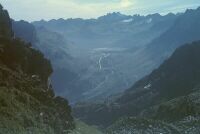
[{"x1": 106, "y1": 88, "x2": 200, "y2": 134}]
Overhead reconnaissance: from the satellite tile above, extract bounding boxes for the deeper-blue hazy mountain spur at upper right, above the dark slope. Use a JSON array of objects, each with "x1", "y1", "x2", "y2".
[{"x1": 147, "y1": 8, "x2": 200, "y2": 60}]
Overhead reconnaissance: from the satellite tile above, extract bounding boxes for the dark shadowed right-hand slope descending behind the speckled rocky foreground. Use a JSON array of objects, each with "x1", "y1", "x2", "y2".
[{"x1": 74, "y1": 42, "x2": 200, "y2": 129}]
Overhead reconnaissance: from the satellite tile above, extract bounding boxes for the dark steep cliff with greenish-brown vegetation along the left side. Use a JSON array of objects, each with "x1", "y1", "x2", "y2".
[{"x1": 0, "y1": 4, "x2": 74, "y2": 134}]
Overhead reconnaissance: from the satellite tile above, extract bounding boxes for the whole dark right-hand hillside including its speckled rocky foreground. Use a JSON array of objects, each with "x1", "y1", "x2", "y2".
[{"x1": 74, "y1": 42, "x2": 200, "y2": 134}]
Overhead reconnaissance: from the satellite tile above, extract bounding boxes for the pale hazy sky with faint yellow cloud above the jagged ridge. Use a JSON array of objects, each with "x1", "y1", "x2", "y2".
[{"x1": 0, "y1": 0, "x2": 200, "y2": 21}]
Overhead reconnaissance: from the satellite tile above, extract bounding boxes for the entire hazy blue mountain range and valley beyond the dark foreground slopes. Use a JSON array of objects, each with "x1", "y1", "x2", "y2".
[{"x1": 13, "y1": 8, "x2": 200, "y2": 103}]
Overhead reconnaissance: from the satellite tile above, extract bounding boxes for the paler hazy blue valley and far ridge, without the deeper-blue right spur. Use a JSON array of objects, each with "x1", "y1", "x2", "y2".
[{"x1": 32, "y1": 13, "x2": 178, "y2": 103}]
